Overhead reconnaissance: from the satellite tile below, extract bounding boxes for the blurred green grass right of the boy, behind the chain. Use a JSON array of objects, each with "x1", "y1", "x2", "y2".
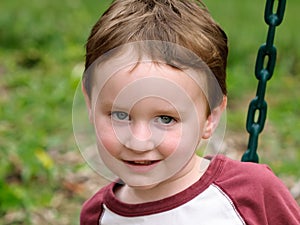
[{"x1": 207, "y1": 0, "x2": 300, "y2": 176}]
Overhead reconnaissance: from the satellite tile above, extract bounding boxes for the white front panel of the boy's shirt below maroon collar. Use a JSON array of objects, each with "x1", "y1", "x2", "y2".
[{"x1": 99, "y1": 185, "x2": 245, "y2": 225}]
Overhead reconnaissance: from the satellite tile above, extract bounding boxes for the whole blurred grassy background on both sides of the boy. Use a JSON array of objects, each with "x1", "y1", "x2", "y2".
[{"x1": 0, "y1": 0, "x2": 300, "y2": 224}]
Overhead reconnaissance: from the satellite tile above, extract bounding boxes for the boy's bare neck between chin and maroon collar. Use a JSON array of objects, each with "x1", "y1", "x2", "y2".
[{"x1": 116, "y1": 155, "x2": 209, "y2": 204}]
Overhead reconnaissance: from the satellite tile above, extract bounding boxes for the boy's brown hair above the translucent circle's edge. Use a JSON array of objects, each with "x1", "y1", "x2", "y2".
[{"x1": 83, "y1": 0, "x2": 228, "y2": 100}]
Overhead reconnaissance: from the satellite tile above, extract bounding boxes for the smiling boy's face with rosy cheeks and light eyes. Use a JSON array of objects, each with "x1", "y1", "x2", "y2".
[{"x1": 84, "y1": 62, "x2": 220, "y2": 186}]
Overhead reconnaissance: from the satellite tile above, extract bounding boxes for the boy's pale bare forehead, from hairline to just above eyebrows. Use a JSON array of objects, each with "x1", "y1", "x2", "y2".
[{"x1": 93, "y1": 62, "x2": 207, "y2": 103}]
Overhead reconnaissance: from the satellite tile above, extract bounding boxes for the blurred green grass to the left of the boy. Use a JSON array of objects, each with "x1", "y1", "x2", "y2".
[{"x1": 0, "y1": 0, "x2": 109, "y2": 224}]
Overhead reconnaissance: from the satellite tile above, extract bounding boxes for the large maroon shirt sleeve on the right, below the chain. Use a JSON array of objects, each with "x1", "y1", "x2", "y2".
[{"x1": 216, "y1": 156, "x2": 300, "y2": 225}]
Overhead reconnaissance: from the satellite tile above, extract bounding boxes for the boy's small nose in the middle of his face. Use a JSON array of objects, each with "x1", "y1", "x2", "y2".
[{"x1": 124, "y1": 122, "x2": 155, "y2": 152}]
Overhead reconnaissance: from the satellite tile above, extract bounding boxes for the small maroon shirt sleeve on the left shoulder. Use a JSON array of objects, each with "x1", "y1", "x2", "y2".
[{"x1": 80, "y1": 185, "x2": 111, "y2": 225}]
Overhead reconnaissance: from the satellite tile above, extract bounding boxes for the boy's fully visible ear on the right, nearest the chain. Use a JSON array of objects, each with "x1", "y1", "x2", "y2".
[{"x1": 202, "y1": 95, "x2": 227, "y2": 139}]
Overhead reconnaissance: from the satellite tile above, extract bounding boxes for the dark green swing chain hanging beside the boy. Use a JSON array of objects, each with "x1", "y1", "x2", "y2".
[{"x1": 242, "y1": 0, "x2": 286, "y2": 163}]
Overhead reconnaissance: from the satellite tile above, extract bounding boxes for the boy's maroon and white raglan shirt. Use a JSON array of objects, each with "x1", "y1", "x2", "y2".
[{"x1": 80, "y1": 155, "x2": 300, "y2": 225}]
